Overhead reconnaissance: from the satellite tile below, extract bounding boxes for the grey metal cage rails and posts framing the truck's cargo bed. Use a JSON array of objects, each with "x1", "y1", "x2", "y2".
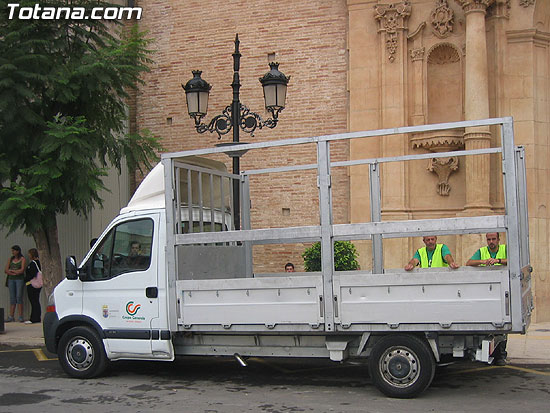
[{"x1": 162, "y1": 118, "x2": 530, "y2": 331}]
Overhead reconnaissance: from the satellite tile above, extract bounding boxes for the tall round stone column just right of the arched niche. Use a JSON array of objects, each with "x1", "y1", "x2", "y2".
[{"x1": 455, "y1": 0, "x2": 495, "y2": 215}]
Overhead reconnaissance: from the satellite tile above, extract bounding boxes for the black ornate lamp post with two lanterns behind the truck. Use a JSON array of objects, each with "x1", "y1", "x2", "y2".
[{"x1": 181, "y1": 34, "x2": 290, "y2": 229}]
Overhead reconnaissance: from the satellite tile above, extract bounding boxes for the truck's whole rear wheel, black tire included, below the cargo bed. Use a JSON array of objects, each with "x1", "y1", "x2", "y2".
[{"x1": 369, "y1": 335, "x2": 435, "y2": 399}]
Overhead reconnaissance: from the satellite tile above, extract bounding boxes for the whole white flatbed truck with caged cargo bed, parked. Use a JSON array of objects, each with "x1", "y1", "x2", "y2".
[{"x1": 44, "y1": 118, "x2": 533, "y2": 398}]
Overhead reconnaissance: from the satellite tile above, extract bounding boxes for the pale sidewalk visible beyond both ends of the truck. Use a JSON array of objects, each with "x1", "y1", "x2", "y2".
[{"x1": 0, "y1": 322, "x2": 550, "y2": 365}]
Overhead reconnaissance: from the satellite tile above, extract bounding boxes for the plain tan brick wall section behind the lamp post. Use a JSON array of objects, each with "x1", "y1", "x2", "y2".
[{"x1": 136, "y1": 0, "x2": 349, "y2": 271}]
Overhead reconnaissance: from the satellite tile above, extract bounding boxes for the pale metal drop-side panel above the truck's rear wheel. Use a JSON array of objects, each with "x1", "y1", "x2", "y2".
[{"x1": 334, "y1": 270, "x2": 511, "y2": 330}]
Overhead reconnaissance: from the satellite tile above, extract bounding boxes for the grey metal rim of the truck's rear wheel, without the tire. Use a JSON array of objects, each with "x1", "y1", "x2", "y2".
[{"x1": 378, "y1": 346, "x2": 420, "y2": 388}]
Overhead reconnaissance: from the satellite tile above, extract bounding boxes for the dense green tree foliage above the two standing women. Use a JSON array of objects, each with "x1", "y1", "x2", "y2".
[{"x1": 0, "y1": 0, "x2": 160, "y2": 290}]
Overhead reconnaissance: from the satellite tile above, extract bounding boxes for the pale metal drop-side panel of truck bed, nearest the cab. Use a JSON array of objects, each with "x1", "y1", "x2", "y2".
[{"x1": 176, "y1": 275, "x2": 324, "y2": 330}]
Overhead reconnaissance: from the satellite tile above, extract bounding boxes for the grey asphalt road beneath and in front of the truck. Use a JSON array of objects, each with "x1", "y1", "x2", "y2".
[{"x1": 0, "y1": 347, "x2": 550, "y2": 413}]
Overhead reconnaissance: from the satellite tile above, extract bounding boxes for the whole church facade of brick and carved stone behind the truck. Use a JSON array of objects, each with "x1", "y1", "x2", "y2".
[{"x1": 130, "y1": 0, "x2": 550, "y2": 321}]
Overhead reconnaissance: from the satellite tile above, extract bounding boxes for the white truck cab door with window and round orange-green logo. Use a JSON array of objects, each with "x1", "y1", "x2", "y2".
[{"x1": 82, "y1": 214, "x2": 171, "y2": 359}]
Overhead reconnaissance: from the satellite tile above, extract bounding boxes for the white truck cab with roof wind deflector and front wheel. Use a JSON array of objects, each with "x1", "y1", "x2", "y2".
[{"x1": 44, "y1": 157, "x2": 233, "y2": 377}]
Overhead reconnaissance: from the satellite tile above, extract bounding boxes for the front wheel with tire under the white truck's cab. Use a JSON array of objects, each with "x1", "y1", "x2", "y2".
[{"x1": 57, "y1": 327, "x2": 108, "y2": 379}]
